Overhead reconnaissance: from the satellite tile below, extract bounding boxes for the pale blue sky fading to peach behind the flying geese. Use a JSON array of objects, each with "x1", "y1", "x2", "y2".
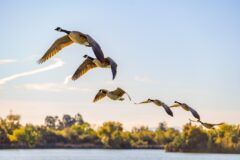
[{"x1": 0, "y1": 0, "x2": 240, "y2": 128}]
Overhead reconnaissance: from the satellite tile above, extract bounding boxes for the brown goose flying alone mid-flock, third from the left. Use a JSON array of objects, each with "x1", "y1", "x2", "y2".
[{"x1": 93, "y1": 88, "x2": 131, "y2": 102}]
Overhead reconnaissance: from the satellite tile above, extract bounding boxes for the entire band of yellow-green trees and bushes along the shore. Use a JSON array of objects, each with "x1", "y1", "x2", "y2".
[{"x1": 0, "y1": 113, "x2": 240, "y2": 153}]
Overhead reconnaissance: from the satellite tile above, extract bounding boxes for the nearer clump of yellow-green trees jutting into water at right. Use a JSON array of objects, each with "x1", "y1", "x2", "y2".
[{"x1": 165, "y1": 123, "x2": 240, "y2": 153}]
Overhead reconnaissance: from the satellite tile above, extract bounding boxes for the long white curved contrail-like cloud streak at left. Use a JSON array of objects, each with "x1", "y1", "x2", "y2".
[{"x1": 0, "y1": 59, "x2": 64, "y2": 85}]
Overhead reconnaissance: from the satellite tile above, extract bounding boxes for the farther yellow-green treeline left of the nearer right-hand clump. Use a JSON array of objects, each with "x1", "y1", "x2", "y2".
[{"x1": 0, "y1": 114, "x2": 179, "y2": 148}]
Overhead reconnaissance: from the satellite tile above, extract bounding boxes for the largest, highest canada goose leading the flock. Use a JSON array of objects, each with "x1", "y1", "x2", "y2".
[{"x1": 38, "y1": 27, "x2": 104, "y2": 63}]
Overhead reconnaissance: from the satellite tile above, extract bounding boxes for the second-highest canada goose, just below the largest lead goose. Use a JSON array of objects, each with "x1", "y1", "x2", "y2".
[{"x1": 72, "y1": 55, "x2": 117, "y2": 80}]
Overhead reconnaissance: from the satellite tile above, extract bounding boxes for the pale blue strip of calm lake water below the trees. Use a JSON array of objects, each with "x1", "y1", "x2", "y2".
[{"x1": 0, "y1": 149, "x2": 240, "y2": 160}]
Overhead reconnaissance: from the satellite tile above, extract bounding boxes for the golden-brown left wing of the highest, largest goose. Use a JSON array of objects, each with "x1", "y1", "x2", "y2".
[{"x1": 38, "y1": 35, "x2": 73, "y2": 64}]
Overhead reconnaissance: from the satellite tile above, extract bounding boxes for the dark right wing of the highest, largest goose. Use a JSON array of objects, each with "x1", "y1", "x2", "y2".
[{"x1": 85, "y1": 34, "x2": 104, "y2": 62}]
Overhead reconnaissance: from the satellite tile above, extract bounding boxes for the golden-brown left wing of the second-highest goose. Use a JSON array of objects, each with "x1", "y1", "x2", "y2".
[{"x1": 72, "y1": 58, "x2": 97, "y2": 80}]
